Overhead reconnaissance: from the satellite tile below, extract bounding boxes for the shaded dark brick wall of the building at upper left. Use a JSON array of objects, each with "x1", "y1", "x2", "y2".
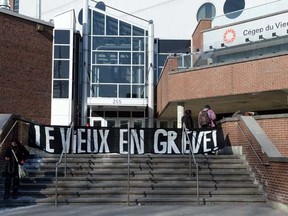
[{"x1": 0, "y1": 12, "x2": 53, "y2": 124}]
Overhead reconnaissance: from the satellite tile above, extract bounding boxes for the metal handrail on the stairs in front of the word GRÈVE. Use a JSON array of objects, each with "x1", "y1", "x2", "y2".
[{"x1": 182, "y1": 123, "x2": 200, "y2": 205}]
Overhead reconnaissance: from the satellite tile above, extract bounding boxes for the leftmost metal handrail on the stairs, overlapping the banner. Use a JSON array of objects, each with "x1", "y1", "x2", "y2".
[{"x1": 55, "y1": 122, "x2": 74, "y2": 206}]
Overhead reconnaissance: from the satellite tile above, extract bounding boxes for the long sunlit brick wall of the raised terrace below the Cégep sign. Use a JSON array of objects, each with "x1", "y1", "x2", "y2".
[{"x1": 157, "y1": 52, "x2": 288, "y2": 113}]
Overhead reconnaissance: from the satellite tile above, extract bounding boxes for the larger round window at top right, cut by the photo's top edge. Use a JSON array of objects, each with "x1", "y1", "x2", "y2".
[{"x1": 223, "y1": 0, "x2": 245, "y2": 19}]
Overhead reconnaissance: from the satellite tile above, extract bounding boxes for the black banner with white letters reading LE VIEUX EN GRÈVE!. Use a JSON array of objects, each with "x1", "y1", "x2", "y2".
[{"x1": 29, "y1": 124, "x2": 224, "y2": 154}]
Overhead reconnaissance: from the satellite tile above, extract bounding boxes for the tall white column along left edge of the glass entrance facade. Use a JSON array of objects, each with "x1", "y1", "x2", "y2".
[{"x1": 81, "y1": 0, "x2": 88, "y2": 126}]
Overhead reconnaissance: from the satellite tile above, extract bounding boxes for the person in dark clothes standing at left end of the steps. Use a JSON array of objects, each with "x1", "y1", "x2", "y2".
[{"x1": 4, "y1": 139, "x2": 29, "y2": 199}]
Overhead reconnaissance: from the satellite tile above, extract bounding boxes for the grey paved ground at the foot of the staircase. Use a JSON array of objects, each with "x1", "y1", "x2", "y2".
[{"x1": 0, "y1": 205, "x2": 288, "y2": 216}]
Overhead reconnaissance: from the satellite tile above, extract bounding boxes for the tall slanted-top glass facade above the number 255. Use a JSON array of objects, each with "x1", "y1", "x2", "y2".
[{"x1": 89, "y1": 10, "x2": 148, "y2": 98}]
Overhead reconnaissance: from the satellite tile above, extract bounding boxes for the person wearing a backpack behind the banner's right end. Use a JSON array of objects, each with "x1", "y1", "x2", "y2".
[{"x1": 198, "y1": 105, "x2": 216, "y2": 128}]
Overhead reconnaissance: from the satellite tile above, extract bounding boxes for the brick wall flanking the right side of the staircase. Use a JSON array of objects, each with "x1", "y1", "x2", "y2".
[{"x1": 222, "y1": 115, "x2": 288, "y2": 205}]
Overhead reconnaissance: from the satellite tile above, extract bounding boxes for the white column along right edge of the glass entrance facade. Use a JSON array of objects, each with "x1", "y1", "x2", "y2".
[{"x1": 147, "y1": 20, "x2": 154, "y2": 128}]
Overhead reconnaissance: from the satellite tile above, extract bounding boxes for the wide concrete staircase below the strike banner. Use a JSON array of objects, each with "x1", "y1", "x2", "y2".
[{"x1": 0, "y1": 154, "x2": 265, "y2": 207}]
